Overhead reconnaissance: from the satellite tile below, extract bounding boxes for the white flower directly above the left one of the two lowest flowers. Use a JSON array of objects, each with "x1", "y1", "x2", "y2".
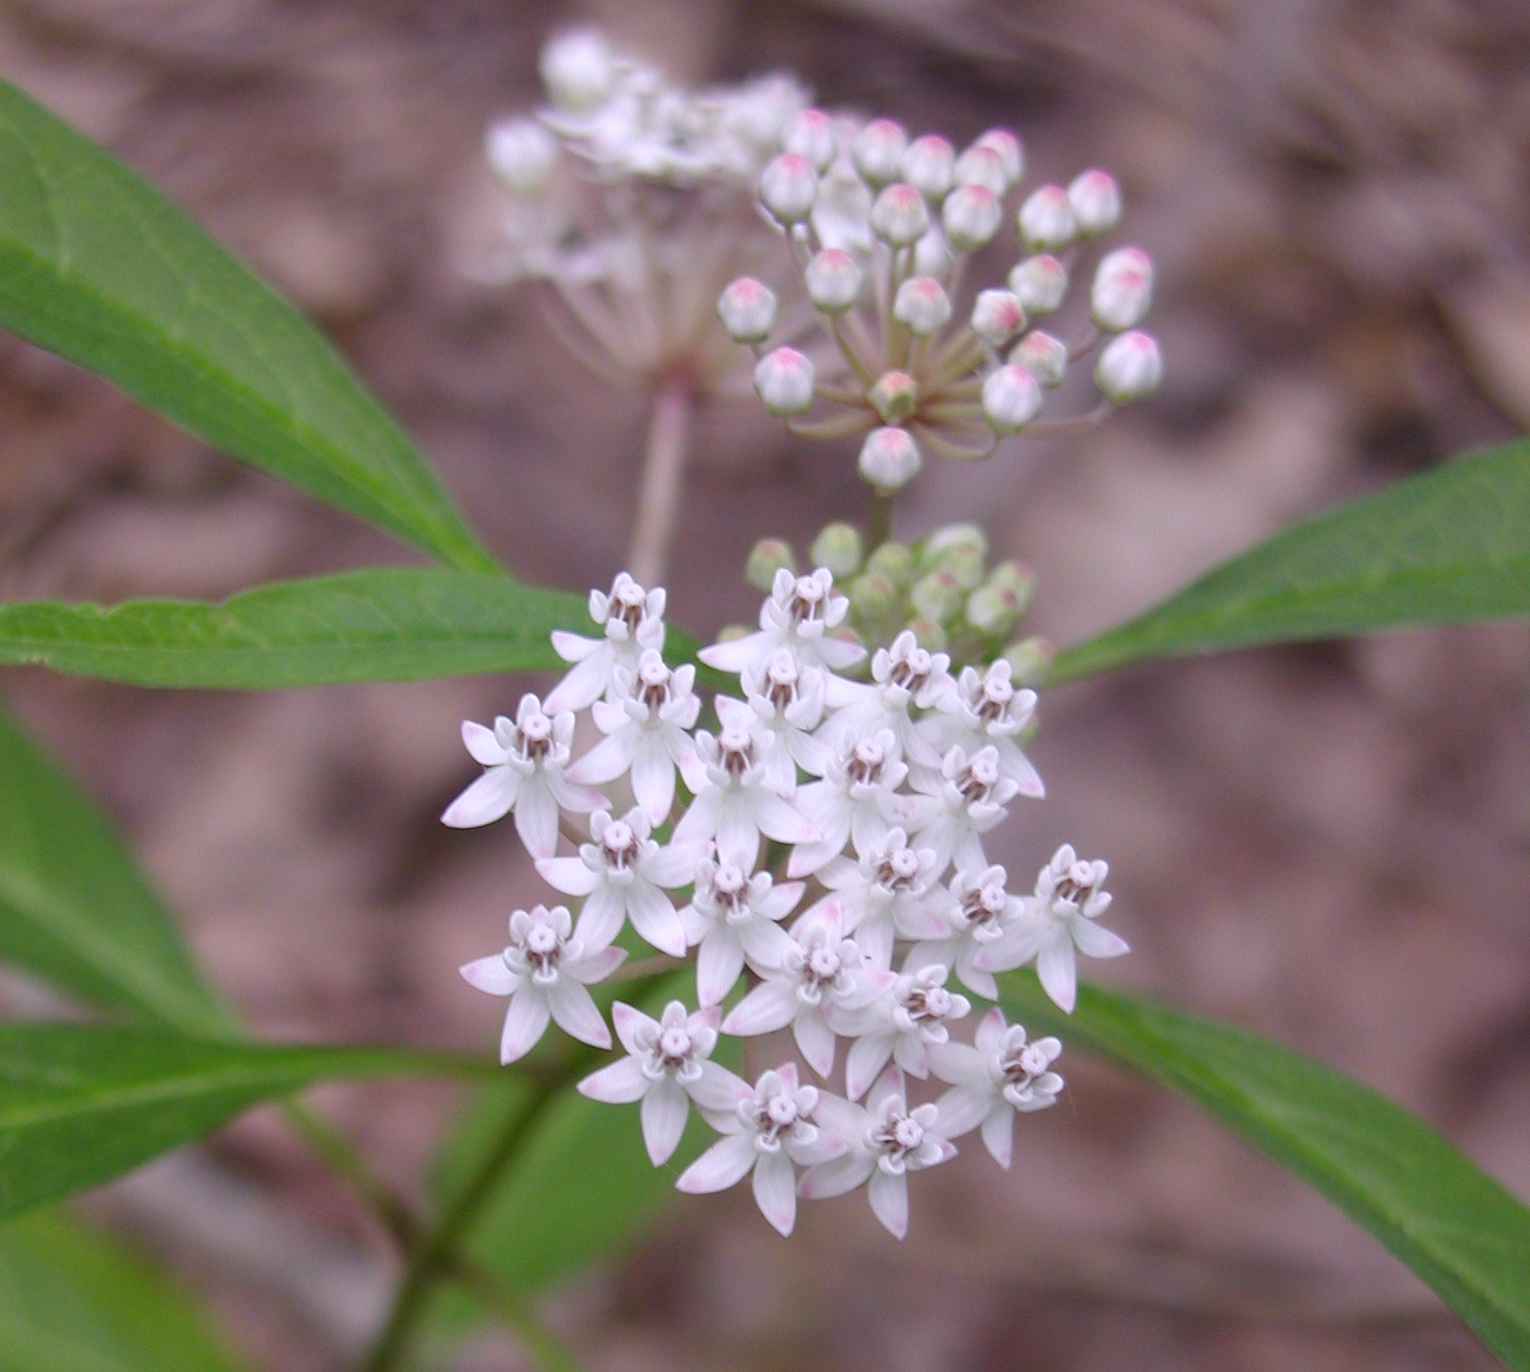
[{"x1": 722, "y1": 912, "x2": 894, "y2": 1077}]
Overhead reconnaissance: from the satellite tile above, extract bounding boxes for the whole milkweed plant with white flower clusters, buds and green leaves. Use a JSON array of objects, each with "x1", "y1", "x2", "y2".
[{"x1": 0, "y1": 21, "x2": 1530, "y2": 1372}]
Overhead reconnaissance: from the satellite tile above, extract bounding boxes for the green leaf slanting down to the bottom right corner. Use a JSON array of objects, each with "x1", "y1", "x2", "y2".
[{"x1": 1001, "y1": 973, "x2": 1530, "y2": 1369}]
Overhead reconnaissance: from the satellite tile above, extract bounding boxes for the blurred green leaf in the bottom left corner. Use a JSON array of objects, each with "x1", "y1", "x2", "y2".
[{"x1": 0, "y1": 1211, "x2": 243, "y2": 1372}]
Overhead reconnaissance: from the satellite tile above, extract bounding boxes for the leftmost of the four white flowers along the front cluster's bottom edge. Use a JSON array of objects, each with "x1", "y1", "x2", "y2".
[{"x1": 578, "y1": 1000, "x2": 748, "y2": 1167}]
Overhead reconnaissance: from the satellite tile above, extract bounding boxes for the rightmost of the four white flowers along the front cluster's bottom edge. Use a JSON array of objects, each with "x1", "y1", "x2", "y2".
[{"x1": 929, "y1": 1006, "x2": 1063, "y2": 1167}]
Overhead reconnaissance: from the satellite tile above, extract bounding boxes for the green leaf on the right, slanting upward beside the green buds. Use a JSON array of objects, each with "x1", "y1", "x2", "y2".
[{"x1": 1051, "y1": 441, "x2": 1530, "y2": 681}]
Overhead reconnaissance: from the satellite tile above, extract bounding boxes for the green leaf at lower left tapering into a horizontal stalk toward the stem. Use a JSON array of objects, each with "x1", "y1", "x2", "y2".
[{"x1": 0, "y1": 1023, "x2": 493, "y2": 1219}]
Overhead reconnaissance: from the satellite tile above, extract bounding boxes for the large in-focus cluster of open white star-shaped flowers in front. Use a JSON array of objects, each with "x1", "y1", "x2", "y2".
[{"x1": 442, "y1": 567, "x2": 1126, "y2": 1237}]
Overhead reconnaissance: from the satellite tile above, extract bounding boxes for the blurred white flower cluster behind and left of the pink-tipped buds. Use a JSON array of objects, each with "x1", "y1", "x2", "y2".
[{"x1": 485, "y1": 29, "x2": 808, "y2": 392}]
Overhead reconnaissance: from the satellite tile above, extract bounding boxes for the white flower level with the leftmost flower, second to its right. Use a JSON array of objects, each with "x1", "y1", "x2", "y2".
[{"x1": 675, "y1": 702, "x2": 820, "y2": 872}]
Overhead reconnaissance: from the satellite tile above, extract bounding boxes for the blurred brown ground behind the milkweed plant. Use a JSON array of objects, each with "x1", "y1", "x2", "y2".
[{"x1": 0, "y1": 0, "x2": 1530, "y2": 1372}]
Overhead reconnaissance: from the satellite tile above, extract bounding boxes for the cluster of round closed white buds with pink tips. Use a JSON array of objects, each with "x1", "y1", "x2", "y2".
[{"x1": 718, "y1": 109, "x2": 1163, "y2": 491}]
